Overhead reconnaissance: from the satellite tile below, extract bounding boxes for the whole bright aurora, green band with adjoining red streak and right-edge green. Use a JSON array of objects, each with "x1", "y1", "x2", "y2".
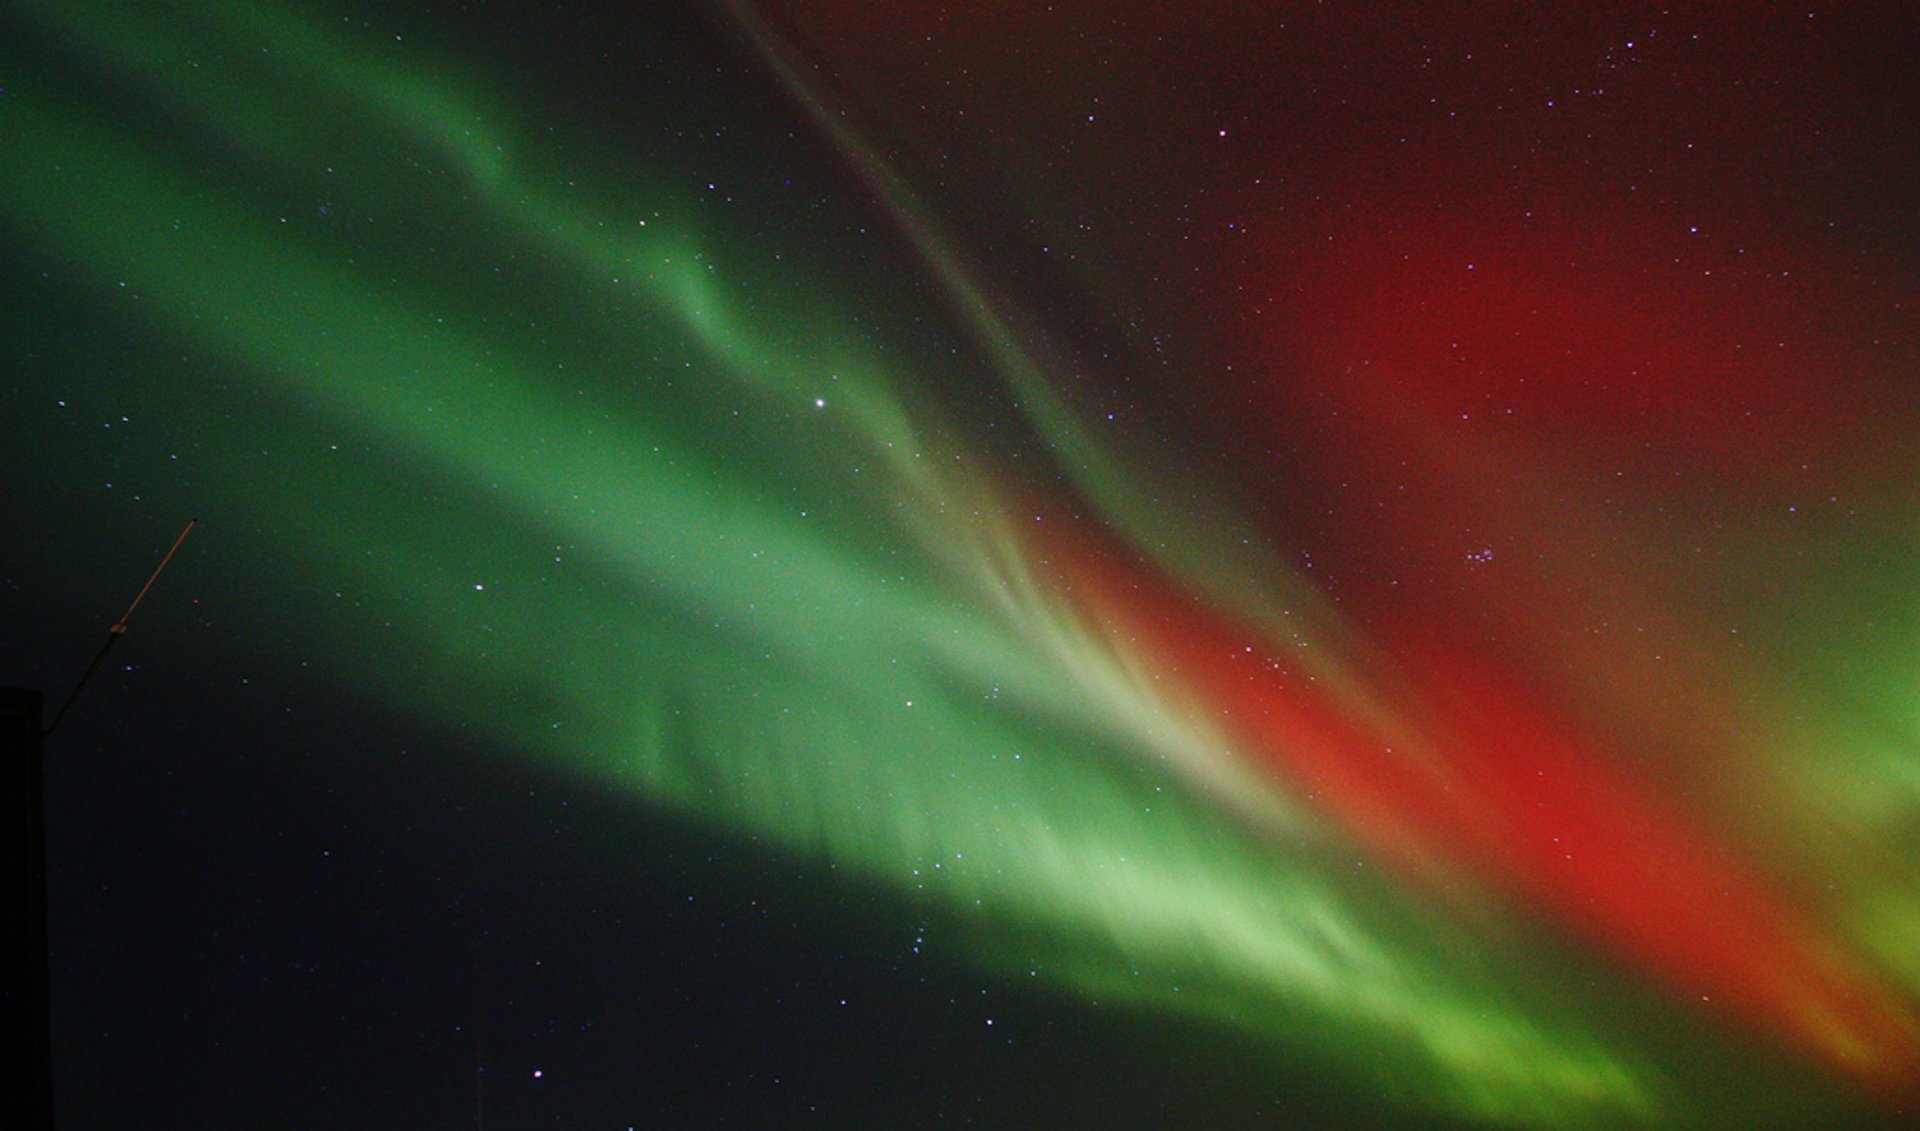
[{"x1": 0, "y1": 4, "x2": 1920, "y2": 1123}]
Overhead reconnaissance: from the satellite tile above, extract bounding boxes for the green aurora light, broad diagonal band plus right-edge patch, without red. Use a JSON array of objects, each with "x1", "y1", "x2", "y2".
[{"x1": 0, "y1": 2, "x2": 1920, "y2": 1125}]
